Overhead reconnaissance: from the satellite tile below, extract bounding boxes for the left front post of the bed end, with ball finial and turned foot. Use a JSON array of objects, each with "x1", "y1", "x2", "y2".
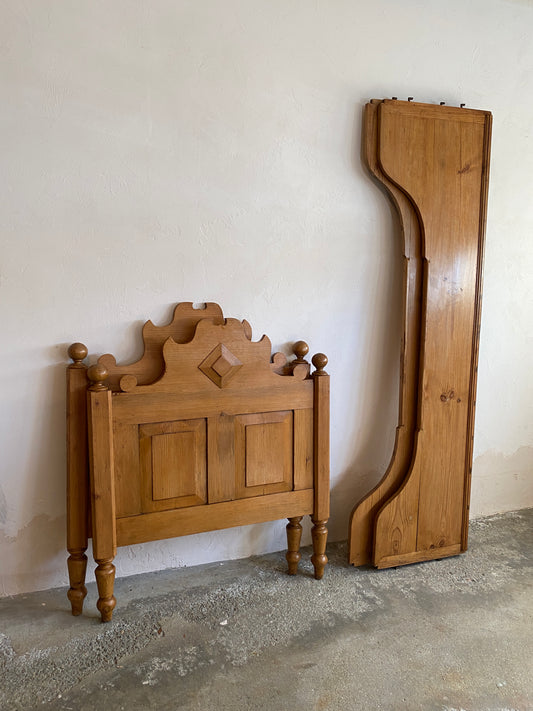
[{"x1": 87, "y1": 364, "x2": 117, "y2": 622}]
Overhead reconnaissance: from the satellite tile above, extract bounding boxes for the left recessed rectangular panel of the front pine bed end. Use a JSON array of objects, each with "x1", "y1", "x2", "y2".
[{"x1": 139, "y1": 420, "x2": 207, "y2": 513}]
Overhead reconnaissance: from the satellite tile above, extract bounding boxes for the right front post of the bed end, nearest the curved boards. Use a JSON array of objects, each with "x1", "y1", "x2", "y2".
[{"x1": 311, "y1": 353, "x2": 329, "y2": 580}]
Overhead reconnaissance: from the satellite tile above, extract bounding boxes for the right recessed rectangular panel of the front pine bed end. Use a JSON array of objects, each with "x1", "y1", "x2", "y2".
[{"x1": 235, "y1": 411, "x2": 293, "y2": 497}]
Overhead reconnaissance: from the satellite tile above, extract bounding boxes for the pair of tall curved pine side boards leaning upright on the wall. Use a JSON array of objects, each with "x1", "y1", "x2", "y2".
[{"x1": 348, "y1": 100, "x2": 492, "y2": 568}]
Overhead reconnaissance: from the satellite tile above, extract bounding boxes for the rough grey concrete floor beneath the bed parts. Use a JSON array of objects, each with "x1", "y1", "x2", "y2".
[{"x1": 0, "y1": 509, "x2": 533, "y2": 711}]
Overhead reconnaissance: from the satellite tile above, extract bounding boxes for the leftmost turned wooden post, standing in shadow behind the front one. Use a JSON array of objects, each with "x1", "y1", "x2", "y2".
[{"x1": 67, "y1": 343, "x2": 89, "y2": 615}]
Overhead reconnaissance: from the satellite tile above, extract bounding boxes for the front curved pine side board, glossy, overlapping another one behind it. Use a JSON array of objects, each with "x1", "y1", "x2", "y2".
[{"x1": 373, "y1": 102, "x2": 491, "y2": 567}]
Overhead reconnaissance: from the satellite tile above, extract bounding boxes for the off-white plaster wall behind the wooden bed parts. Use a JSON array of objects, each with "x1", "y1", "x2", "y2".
[{"x1": 0, "y1": 0, "x2": 533, "y2": 595}]
